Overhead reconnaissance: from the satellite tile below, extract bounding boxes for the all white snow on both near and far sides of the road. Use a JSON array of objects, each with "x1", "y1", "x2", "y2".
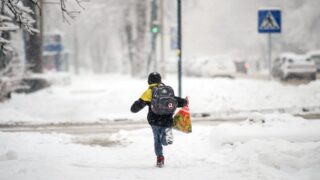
[{"x1": 0, "y1": 75, "x2": 320, "y2": 180}]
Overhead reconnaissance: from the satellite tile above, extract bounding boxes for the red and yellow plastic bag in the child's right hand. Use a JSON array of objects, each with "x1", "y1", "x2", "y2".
[{"x1": 173, "y1": 105, "x2": 192, "y2": 133}]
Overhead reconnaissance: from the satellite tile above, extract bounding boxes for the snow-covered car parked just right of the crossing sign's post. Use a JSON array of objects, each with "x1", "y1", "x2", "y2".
[{"x1": 272, "y1": 53, "x2": 316, "y2": 80}]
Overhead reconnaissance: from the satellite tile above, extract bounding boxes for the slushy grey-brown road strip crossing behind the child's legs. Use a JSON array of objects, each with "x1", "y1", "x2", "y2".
[{"x1": 0, "y1": 113, "x2": 320, "y2": 135}]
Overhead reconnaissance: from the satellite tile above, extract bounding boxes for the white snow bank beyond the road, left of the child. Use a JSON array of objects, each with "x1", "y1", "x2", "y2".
[{"x1": 0, "y1": 75, "x2": 146, "y2": 124}]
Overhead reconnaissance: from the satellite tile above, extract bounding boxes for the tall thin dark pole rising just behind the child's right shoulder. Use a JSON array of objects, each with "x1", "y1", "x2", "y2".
[{"x1": 177, "y1": 0, "x2": 182, "y2": 97}]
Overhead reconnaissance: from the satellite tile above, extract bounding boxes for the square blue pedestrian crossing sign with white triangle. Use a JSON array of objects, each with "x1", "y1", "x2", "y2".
[{"x1": 258, "y1": 9, "x2": 281, "y2": 33}]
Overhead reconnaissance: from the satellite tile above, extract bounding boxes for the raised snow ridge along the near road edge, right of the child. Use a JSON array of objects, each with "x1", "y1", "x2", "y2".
[{"x1": 211, "y1": 113, "x2": 320, "y2": 146}]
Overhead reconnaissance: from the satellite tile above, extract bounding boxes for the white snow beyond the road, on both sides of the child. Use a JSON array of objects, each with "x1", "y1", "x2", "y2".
[{"x1": 0, "y1": 75, "x2": 320, "y2": 124}]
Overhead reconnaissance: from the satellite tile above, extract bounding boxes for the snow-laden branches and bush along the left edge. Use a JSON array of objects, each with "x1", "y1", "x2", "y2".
[{"x1": 0, "y1": 0, "x2": 38, "y2": 101}]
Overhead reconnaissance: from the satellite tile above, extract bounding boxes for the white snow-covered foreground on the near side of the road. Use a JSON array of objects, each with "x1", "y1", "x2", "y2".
[{"x1": 0, "y1": 114, "x2": 320, "y2": 180}]
